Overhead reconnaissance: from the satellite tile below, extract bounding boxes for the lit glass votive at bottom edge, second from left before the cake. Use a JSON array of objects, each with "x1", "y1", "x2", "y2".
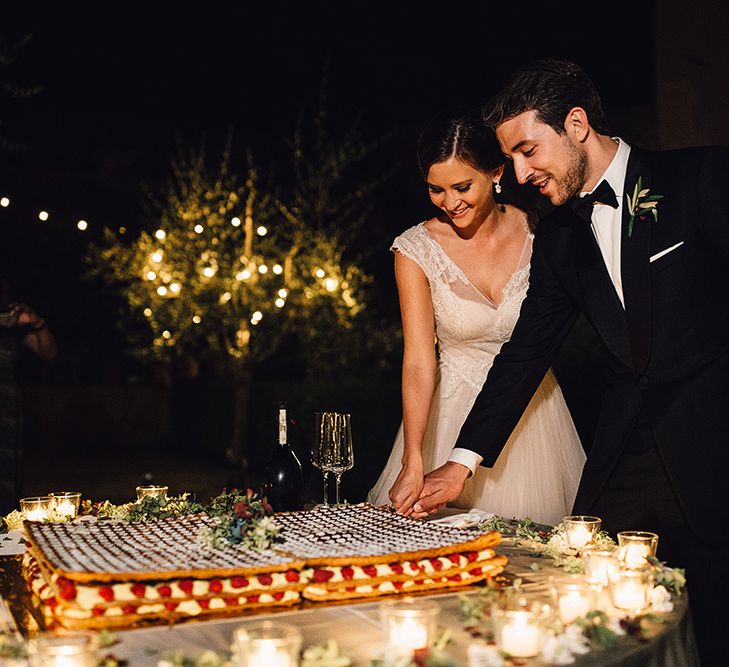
[{"x1": 234, "y1": 621, "x2": 302, "y2": 667}]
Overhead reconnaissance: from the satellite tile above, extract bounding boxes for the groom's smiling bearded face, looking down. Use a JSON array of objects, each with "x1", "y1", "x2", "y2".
[{"x1": 496, "y1": 111, "x2": 587, "y2": 206}]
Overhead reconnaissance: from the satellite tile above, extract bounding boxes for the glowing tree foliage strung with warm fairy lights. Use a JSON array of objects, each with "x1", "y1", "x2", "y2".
[{"x1": 79, "y1": 147, "x2": 363, "y2": 362}]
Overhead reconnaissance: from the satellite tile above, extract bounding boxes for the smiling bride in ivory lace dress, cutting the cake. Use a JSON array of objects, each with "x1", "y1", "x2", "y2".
[{"x1": 367, "y1": 111, "x2": 585, "y2": 525}]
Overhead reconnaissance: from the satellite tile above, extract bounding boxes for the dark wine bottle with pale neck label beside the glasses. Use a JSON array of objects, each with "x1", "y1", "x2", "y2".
[{"x1": 263, "y1": 403, "x2": 304, "y2": 512}]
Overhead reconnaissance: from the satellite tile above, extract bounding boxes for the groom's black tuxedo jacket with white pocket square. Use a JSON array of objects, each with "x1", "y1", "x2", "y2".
[{"x1": 455, "y1": 146, "x2": 729, "y2": 536}]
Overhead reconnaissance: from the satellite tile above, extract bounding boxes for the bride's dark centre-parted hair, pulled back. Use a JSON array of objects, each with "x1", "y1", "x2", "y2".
[{"x1": 417, "y1": 111, "x2": 504, "y2": 179}]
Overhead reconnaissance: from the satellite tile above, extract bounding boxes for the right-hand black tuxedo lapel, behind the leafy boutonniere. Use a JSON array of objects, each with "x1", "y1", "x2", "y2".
[{"x1": 620, "y1": 149, "x2": 654, "y2": 371}]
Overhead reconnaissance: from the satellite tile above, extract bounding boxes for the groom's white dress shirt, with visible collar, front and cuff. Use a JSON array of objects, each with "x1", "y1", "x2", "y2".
[{"x1": 448, "y1": 137, "x2": 630, "y2": 475}]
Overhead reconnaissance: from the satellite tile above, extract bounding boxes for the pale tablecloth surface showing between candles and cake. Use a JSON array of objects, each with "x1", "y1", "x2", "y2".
[{"x1": 0, "y1": 539, "x2": 700, "y2": 667}]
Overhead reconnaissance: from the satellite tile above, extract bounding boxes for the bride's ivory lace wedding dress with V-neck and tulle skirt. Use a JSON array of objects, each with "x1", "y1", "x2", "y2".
[{"x1": 367, "y1": 223, "x2": 585, "y2": 525}]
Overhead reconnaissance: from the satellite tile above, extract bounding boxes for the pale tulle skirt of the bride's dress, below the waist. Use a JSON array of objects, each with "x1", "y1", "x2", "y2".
[{"x1": 367, "y1": 370, "x2": 585, "y2": 525}]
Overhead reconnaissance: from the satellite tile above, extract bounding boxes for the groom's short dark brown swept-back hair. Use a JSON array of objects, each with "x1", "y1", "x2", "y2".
[{"x1": 481, "y1": 58, "x2": 610, "y2": 134}]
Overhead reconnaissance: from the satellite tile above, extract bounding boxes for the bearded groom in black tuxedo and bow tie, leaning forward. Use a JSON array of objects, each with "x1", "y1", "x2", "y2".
[{"x1": 414, "y1": 60, "x2": 729, "y2": 664}]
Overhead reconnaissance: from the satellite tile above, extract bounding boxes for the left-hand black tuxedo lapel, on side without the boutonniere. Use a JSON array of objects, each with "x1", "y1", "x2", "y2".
[{"x1": 565, "y1": 211, "x2": 631, "y2": 365}]
